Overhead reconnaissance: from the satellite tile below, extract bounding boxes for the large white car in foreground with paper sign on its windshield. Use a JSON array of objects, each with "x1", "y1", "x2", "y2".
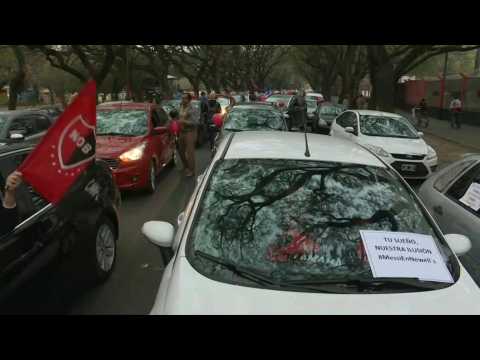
[{"x1": 142, "y1": 132, "x2": 480, "y2": 315}]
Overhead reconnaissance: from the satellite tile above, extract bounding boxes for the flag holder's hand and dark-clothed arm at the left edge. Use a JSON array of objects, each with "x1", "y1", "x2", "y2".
[{"x1": 0, "y1": 171, "x2": 22, "y2": 238}]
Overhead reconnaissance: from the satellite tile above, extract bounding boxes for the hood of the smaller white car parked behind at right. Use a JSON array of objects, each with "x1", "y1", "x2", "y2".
[{"x1": 358, "y1": 136, "x2": 428, "y2": 155}]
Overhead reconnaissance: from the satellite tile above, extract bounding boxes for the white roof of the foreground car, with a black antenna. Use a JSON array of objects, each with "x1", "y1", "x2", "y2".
[{"x1": 225, "y1": 131, "x2": 386, "y2": 168}]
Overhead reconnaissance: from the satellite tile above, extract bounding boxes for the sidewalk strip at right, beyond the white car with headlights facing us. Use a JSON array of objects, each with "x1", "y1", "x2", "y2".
[{"x1": 397, "y1": 110, "x2": 480, "y2": 151}]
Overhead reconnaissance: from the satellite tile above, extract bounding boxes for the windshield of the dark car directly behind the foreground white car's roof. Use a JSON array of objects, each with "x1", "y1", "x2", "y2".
[{"x1": 224, "y1": 108, "x2": 284, "y2": 131}]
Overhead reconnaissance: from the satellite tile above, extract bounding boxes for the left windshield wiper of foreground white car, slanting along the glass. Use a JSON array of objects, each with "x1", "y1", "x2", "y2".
[{"x1": 195, "y1": 250, "x2": 335, "y2": 293}]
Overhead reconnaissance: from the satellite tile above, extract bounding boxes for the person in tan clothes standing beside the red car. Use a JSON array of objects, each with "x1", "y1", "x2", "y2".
[{"x1": 178, "y1": 94, "x2": 198, "y2": 177}]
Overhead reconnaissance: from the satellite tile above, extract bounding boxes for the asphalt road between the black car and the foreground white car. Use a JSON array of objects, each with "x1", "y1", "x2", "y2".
[{"x1": 0, "y1": 147, "x2": 210, "y2": 315}]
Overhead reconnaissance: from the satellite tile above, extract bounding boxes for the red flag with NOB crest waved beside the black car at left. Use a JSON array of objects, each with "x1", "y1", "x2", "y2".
[{"x1": 18, "y1": 80, "x2": 97, "y2": 205}]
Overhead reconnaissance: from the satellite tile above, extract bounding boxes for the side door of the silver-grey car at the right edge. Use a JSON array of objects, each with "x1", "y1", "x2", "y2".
[{"x1": 432, "y1": 163, "x2": 480, "y2": 259}]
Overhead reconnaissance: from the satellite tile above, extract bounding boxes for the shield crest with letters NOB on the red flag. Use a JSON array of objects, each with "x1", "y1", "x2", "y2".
[{"x1": 58, "y1": 115, "x2": 95, "y2": 170}]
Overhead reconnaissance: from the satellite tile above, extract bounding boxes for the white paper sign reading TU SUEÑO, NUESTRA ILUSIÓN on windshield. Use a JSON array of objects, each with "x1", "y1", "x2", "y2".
[{"x1": 360, "y1": 230, "x2": 453, "y2": 283}]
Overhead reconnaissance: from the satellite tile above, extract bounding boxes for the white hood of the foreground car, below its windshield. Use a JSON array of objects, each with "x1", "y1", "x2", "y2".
[{"x1": 151, "y1": 257, "x2": 480, "y2": 315}]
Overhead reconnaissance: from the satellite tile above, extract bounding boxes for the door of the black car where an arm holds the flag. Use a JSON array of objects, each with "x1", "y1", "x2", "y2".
[{"x1": 0, "y1": 150, "x2": 57, "y2": 297}]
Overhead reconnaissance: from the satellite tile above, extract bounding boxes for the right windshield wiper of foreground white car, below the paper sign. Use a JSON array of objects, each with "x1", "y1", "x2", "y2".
[{"x1": 289, "y1": 278, "x2": 450, "y2": 290}]
